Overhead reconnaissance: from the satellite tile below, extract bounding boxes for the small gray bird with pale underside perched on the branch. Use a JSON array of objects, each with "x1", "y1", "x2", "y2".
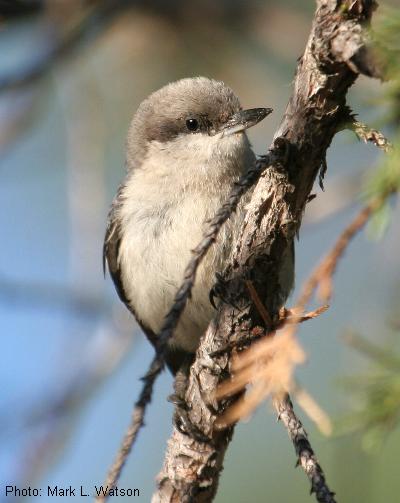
[{"x1": 103, "y1": 77, "x2": 272, "y2": 373}]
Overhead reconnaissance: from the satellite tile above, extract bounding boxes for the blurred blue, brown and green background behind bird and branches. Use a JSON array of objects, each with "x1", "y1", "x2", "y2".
[{"x1": 0, "y1": 0, "x2": 400, "y2": 503}]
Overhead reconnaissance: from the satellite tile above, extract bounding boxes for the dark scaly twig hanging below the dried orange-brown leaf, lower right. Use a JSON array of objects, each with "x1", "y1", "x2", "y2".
[{"x1": 274, "y1": 394, "x2": 336, "y2": 503}]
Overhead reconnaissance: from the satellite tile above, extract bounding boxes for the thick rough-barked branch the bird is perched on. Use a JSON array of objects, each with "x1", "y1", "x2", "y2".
[{"x1": 152, "y1": 0, "x2": 375, "y2": 503}]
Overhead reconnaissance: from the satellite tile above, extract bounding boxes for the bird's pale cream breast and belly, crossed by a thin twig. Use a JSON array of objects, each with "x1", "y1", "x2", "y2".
[{"x1": 119, "y1": 135, "x2": 254, "y2": 352}]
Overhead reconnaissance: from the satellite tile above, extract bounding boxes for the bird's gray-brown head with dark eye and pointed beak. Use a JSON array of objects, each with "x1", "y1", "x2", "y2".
[{"x1": 127, "y1": 77, "x2": 272, "y2": 175}]
